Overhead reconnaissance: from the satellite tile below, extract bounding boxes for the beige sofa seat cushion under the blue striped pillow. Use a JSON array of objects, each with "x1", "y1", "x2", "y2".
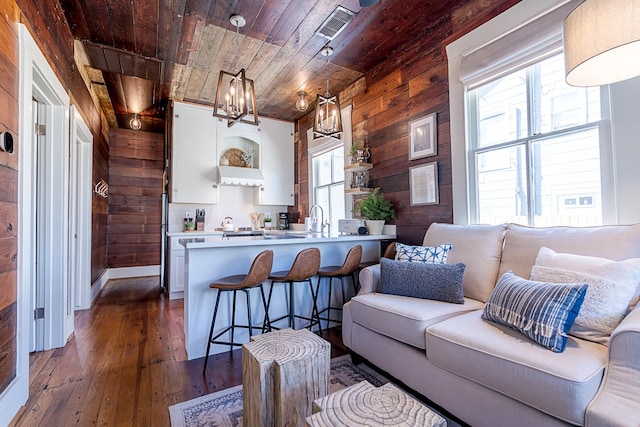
[{"x1": 426, "y1": 311, "x2": 607, "y2": 425}]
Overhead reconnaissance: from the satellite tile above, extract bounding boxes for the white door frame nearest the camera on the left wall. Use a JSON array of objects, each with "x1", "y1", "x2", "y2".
[{"x1": 0, "y1": 24, "x2": 70, "y2": 425}]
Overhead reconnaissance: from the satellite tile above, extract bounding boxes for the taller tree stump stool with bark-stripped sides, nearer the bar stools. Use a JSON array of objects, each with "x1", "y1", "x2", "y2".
[{"x1": 242, "y1": 329, "x2": 331, "y2": 427}]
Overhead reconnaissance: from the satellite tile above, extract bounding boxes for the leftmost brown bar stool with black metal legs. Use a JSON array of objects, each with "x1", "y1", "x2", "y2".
[{"x1": 202, "y1": 250, "x2": 273, "y2": 375}]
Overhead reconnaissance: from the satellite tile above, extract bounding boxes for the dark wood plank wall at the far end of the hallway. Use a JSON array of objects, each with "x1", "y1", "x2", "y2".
[{"x1": 108, "y1": 128, "x2": 164, "y2": 267}]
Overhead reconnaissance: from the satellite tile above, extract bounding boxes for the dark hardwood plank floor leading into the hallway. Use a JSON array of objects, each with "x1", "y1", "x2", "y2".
[{"x1": 10, "y1": 277, "x2": 346, "y2": 427}]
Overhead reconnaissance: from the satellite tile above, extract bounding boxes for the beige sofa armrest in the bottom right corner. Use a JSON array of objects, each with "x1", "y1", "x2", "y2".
[{"x1": 585, "y1": 305, "x2": 640, "y2": 427}]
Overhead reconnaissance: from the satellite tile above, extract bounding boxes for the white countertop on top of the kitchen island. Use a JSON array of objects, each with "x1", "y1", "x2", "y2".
[{"x1": 178, "y1": 231, "x2": 396, "y2": 249}]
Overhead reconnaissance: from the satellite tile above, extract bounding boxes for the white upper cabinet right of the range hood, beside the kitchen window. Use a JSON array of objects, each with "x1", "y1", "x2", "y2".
[{"x1": 254, "y1": 118, "x2": 295, "y2": 206}]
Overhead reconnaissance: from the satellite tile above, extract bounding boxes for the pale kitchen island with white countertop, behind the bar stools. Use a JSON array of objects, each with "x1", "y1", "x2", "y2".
[{"x1": 179, "y1": 232, "x2": 396, "y2": 359}]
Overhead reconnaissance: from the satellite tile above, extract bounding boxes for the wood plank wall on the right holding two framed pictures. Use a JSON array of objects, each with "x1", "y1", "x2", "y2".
[{"x1": 292, "y1": 0, "x2": 519, "y2": 244}]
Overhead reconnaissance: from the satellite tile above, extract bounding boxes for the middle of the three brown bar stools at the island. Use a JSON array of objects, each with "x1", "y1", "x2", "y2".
[{"x1": 264, "y1": 248, "x2": 320, "y2": 330}]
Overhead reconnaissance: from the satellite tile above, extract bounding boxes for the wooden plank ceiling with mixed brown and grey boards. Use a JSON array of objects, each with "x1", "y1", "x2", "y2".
[{"x1": 60, "y1": 0, "x2": 468, "y2": 132}]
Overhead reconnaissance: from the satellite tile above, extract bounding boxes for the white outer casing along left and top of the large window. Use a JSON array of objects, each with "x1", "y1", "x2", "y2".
[{"x1": 446, "y1": 0, "x2": 606, "y2": 224}]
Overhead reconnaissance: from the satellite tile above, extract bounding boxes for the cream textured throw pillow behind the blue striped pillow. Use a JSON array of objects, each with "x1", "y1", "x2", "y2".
[{"x1": 532, "y1": 247, "x2": 640, "y2": 342}]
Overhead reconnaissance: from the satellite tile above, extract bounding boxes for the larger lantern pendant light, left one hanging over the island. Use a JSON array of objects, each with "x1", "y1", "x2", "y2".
[{"x1": 213, "y1": 15, "x2": 258, "y2": 127}]
